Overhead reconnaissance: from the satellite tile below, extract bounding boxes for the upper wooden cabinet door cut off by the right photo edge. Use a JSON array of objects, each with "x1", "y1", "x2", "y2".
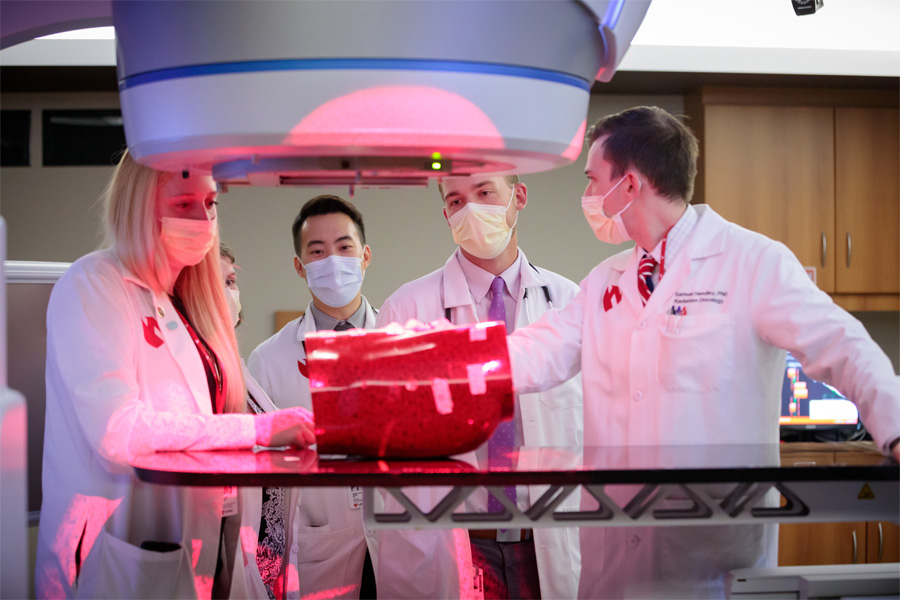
[{"x1": 835, "y1": 108, "x2": 900, "y2": 293}]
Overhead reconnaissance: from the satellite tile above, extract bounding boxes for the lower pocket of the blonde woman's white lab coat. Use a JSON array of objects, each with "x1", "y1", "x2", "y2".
[{"x1": 75, "y1": 531, "x2": 197, "y2": 598}]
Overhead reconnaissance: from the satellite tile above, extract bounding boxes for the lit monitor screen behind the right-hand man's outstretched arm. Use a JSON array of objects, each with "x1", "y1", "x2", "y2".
[{"x1": 780, "y1": 352, "x2": 859, "y2": 429}]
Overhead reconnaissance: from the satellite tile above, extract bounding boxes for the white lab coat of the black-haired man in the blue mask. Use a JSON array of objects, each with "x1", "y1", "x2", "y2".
[{"x1": 247, "y1": 298, "x2": 381, "y2": 598}]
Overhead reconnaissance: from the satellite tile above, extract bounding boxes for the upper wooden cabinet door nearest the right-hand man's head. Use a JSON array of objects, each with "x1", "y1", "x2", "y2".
[{"x1": 703, "y1": 105, "x2": 835, "y2": 292}]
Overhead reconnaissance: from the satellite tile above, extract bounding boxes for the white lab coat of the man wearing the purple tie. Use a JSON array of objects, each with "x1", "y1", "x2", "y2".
[{"x1": 378, "y1": 249, "x2": 583, "y2": 598}]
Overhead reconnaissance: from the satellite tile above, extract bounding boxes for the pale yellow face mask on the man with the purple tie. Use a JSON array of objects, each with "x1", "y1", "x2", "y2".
[{"x1": 449, "y1": 186, "x2": 519, "y2": 260}]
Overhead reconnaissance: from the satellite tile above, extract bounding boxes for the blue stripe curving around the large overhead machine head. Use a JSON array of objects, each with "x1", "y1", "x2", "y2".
[{"x1": 119, "y1": 58, "x2": 591, "y2": 91}]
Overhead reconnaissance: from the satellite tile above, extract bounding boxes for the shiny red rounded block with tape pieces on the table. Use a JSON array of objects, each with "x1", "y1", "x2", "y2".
[{"x1": 306, "y1": 323, "x2": 513, "y2": 457}]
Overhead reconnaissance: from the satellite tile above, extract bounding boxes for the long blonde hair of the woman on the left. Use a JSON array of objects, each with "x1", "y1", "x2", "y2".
[{"x1": 103, "y1": 151, "x2": 246, "y2": 413}]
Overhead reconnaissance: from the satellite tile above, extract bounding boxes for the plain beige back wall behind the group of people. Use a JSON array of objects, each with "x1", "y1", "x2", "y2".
[{"x1": 0, "y1": 93, "x2": 900, "y2": 370}]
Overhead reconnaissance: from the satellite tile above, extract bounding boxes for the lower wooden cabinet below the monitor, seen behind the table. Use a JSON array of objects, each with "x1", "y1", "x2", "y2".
[{"x1": 778, "y1": 443, "x2": 900, "y2": 566}]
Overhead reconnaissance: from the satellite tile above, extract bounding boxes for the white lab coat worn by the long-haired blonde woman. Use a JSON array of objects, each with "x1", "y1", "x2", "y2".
[{"x1": 35, "y1": 250, "x2": 256, "y2": 598}]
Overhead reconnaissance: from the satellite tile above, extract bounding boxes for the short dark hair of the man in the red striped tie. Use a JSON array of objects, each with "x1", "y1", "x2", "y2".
[{"x1": 585, "y1": 106, "x2": 700, "y2": 202}]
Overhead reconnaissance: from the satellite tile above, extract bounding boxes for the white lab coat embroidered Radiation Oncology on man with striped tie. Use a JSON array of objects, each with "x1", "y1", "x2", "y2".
[{"x1": 509, "y1": 206, "x2": 900, "y2": 598}]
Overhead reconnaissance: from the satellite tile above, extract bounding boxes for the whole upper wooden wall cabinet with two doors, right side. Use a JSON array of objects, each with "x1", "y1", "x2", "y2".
[{"x1": 685, "y1": 88, "x2": 900, "y2": 310}]
